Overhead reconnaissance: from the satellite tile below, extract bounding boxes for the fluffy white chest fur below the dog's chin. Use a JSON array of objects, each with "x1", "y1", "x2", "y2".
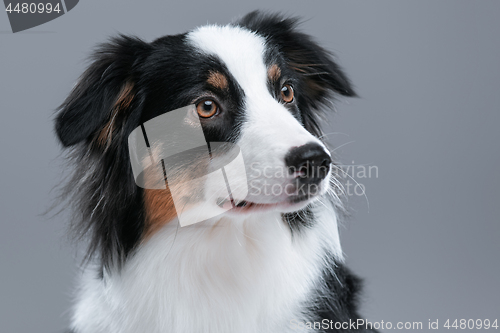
[{"x1": 72, "y1": 207, "x2": 342, "y2": 333}]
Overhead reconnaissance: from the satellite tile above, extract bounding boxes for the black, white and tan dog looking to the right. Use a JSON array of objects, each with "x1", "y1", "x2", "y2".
[{"x1": 55, "y1": 11, "x2": 375, "y2": 333}]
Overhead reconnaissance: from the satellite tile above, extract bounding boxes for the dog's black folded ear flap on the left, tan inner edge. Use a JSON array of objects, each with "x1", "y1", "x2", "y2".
[{"x1": 55, "y1": 35, "x2": 150, "y2": 147}]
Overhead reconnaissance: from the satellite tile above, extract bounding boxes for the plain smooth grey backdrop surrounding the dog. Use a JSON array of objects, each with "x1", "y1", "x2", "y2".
[{"x1": 0, "y1": 0, "x2": 500, "y2": 333}]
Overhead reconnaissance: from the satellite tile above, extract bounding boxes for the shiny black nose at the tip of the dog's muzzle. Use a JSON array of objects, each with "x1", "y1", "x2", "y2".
[{"x1": 285, "y1": 142, "x2": 332, "y2": 184}]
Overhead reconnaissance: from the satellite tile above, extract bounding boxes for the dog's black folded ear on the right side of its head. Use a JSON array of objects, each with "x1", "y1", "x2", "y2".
[{"x1": 238, "y1": 11, "x2": 356, "y2": 107}]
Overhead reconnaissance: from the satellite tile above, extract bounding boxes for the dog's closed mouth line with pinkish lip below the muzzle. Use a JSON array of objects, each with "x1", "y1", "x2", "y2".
[{"x1": 217, "y1": 195, "x2": 311, "y2": 214}]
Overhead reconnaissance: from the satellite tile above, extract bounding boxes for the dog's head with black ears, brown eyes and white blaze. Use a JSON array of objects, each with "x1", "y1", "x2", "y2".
[{"x1": 56, "y1": 12, "x2": 354, "y2": 264}]
